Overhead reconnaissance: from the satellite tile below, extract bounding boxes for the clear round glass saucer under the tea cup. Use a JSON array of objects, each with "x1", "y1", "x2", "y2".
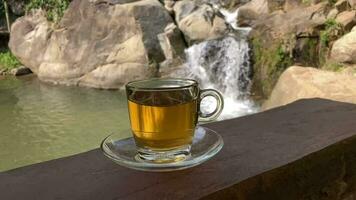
[{"x1": 101, "y1": 126, "x2": 224, "y2": 172}]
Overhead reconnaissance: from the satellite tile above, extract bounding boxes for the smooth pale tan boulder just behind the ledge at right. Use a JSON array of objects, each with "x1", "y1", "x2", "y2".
[{"x1": 262, "y1": 66, "x2": 356, "y2": 110}]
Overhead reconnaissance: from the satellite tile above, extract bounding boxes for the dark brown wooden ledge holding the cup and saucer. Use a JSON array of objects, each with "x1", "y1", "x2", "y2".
[{"x1": 0, "y1": 99, "x2": 356, "y2": 200}]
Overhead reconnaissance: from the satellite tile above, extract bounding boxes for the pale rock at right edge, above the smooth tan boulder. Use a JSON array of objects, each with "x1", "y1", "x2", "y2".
[{"x1": 331, "y1": 26, "x2": 356, "y2": 64}]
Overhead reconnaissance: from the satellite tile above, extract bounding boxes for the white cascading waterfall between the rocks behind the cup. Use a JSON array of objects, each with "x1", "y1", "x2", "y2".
[{"x1": 174, "y1": 6, "x2": 258, "y2": 120}]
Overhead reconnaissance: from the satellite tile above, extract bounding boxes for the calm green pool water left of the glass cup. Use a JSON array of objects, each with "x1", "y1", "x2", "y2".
[{"x1": 0, "y1": 76, "x2": 130, "y2": 171}]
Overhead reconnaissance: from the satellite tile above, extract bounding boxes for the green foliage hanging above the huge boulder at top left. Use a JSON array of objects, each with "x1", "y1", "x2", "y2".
[{"x1": 26, "y1": 0, "x2": 70, "y2": 23}]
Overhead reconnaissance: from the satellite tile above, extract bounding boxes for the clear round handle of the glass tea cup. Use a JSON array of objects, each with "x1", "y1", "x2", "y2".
[{"x1": 199, "y1": 89, "x2": 224, "y2": 122}]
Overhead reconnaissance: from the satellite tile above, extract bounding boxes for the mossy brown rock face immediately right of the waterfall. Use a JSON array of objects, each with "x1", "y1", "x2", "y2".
[{"x1": 250, "y1": 3, "x2": 327, "y2": 97}]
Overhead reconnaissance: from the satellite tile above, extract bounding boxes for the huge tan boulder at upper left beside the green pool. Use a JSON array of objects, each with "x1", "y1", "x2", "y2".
[{"x1": 9, "y1": 0, "x2": 184, "y2": 88}]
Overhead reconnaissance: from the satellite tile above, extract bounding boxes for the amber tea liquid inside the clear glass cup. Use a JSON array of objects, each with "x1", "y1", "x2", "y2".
[{"x1": 128, "y1": 92, "x2": 198, "y2": 150}]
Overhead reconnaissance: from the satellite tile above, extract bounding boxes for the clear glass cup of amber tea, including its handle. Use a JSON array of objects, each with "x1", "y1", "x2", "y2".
[{"x1": 126, "y1": 78, "x2": 223, "y2": 163}]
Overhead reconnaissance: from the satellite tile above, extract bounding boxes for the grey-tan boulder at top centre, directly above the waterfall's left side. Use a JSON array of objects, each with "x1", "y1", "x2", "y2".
[{"x1": 173, "y1": 0, "x2": 228, "y2": 45}]
